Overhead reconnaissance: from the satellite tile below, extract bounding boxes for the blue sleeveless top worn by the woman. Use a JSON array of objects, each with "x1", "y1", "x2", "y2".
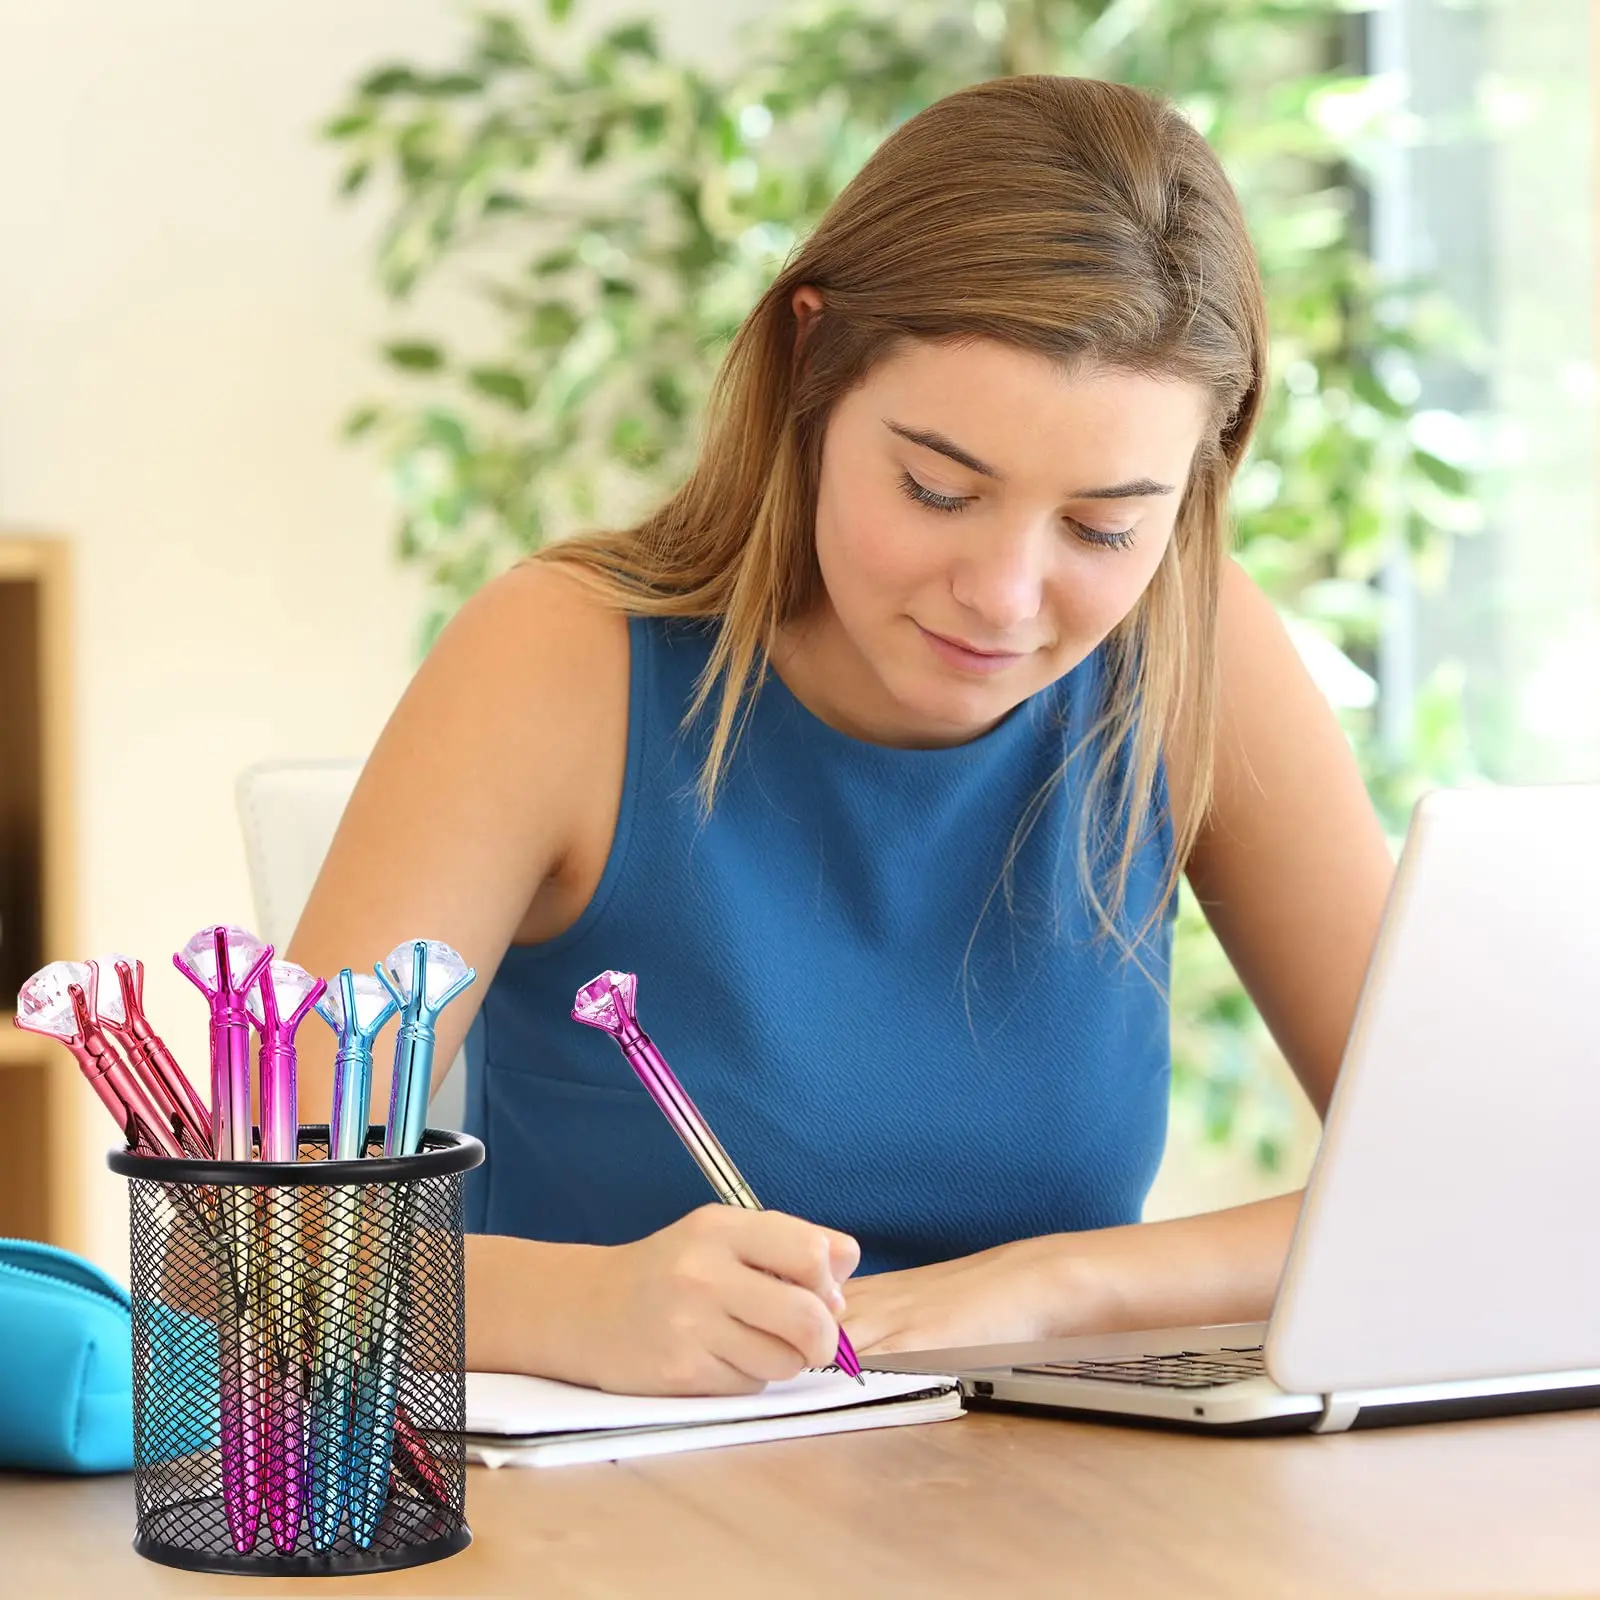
[{"x1": 467, "y1": 618, "x2": 1173, "y2": 1272}]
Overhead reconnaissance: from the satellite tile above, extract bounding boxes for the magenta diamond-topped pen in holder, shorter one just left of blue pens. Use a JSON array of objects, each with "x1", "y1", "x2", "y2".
[{"x1": 245, "y1": 962, "x2": 328, "y2": 1555}]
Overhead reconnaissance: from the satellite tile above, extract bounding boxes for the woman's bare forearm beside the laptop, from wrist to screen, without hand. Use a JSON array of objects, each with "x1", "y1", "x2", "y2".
[{"x1": 1027, "y1": 1190, "x2": 1301, "y2": 1338}]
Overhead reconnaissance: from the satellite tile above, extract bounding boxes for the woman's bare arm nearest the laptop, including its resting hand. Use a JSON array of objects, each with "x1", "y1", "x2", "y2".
[{"x1": 845, "y1": 562, "x2": 1394, "y2": 1350}]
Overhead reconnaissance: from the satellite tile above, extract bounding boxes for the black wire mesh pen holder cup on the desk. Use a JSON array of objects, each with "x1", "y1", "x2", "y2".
[{"x1": 109, "y1": 1126, "x2": 483, "y2": 1578}]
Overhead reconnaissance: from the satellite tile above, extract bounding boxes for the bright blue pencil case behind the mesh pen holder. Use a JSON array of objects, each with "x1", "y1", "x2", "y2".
[{"x1": 0, "y1": 1238, "x2": 216, "y2": 1472}]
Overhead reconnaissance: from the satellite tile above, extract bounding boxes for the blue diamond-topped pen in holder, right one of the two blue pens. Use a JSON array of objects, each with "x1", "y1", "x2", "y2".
[{"x1": 349, "y1": 939, "x2": 477, "y2": 1547}]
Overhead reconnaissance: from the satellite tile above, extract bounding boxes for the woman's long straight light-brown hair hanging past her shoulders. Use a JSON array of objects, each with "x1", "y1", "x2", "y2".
[{"x1": 536, "y1": 77, "x2": 1267, "y2": 950}]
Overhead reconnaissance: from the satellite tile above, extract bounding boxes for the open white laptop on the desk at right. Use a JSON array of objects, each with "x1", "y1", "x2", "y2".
[{"x1": 864, "y1": 784, "x2": 1600, "y2": 1434}]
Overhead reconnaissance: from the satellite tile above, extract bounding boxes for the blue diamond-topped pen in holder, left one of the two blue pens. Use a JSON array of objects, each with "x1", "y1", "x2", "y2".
[{"x1": 307, "y1": 966, "x2": 398, "y2": 1550}]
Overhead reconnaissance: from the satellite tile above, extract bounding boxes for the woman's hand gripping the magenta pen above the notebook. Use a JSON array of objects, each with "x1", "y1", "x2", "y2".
[{"x1": 547, "y1": 1205, "x2": 861, "y2": 1395}]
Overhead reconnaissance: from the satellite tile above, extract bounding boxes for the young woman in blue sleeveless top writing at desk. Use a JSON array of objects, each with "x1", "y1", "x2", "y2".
[{"x1": 290, "y1": 77, "x2": 1390, "y2": 1392}]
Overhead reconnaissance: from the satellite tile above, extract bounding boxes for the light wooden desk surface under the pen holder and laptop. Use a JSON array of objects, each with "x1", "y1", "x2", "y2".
[{"x1": 0, "y1": 1411, "x2": 1600, "y2": 1600}]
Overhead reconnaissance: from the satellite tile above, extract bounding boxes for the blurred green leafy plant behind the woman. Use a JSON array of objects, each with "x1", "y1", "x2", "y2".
[{"x1": 326, "y1": 0, "x2": 1478, "y2": 1170}]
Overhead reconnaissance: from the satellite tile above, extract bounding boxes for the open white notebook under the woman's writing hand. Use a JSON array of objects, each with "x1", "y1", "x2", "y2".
[{"x1": 467, "y1": 1371, "x2": 962, "y2": 1467}]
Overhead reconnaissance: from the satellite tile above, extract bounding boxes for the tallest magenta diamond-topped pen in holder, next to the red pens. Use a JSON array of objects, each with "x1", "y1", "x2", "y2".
[{"x1": 173, "y1": 926, "x2": 272, "y2": 1555}]
